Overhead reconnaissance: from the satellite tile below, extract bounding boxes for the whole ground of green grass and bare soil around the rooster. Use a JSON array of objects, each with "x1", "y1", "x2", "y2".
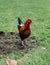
[{"x1": 0, "y1": 0, "x2": 50, "y2": 65}]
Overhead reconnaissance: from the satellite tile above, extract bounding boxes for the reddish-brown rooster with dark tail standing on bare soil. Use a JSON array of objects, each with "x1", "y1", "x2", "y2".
[{"x1": 18, "y1": 17, "x2": 32, "y2": 46}]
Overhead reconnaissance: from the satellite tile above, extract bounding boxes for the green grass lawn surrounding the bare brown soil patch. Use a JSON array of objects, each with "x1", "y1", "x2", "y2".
[{"x1": 0, "y1": 0, "x2": 50, "y2": 65}]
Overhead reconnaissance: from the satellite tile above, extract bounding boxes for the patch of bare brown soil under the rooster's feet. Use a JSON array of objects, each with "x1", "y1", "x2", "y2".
[{"x1": 0, "y1": 31, "x2": 38, "y2": 58}]
